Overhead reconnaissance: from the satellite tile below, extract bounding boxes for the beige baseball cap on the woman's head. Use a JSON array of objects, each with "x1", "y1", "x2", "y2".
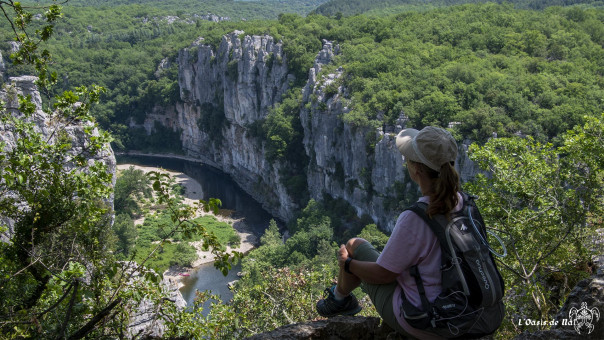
[{"x1": 396, "y1": 126, "x2": 457, "y2": 171}]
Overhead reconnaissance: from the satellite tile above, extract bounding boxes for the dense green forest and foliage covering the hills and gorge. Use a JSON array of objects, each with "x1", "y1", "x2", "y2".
[{"x1": 0, "y1": 0, "x2": 604, "y2": 339}]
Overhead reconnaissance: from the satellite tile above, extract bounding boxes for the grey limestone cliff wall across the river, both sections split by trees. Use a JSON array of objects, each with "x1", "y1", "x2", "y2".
[{"x1": 145, "y1": 31, "x2": 476, "y2": 230}]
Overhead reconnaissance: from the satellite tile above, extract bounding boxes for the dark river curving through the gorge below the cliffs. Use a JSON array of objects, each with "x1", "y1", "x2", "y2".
[{"x1": 116, "y1": 156, "x2": 273, "y2": 314}]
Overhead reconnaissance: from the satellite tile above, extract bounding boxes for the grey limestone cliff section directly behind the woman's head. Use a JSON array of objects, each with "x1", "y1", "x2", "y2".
[{"x1": 300, "y1": 41, "x2": 477, "y2": 230}]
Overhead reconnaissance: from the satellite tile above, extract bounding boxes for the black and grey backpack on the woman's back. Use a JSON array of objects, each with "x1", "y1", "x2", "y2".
[{"x1": 401, "y1": 194, "x2": 505, "y2": 339}]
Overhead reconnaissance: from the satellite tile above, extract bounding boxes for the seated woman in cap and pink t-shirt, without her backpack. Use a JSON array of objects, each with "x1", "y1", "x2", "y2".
[{"x1": 317, "y1": 126, "x2": 463, "y2": 339}]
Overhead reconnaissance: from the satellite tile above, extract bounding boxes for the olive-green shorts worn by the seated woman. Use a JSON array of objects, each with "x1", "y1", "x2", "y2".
[{"x1": 353, "y1": 242, "x2": 407, "y2": 335}]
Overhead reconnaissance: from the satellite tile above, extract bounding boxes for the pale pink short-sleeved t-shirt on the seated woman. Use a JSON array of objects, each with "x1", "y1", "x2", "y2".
[{"x1": 376, "y1": 193, "x2": 463, "y2": 339}]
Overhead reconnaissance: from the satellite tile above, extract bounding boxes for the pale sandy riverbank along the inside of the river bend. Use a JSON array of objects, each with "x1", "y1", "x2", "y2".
[{"x1": 117, "y1": 164, "x2": 258, "y2": 286}]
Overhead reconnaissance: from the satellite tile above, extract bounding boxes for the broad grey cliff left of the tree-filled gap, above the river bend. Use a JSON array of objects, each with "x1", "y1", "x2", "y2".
[{"x1": 160, "y1": 31, "x2": 297, "y2": 220}]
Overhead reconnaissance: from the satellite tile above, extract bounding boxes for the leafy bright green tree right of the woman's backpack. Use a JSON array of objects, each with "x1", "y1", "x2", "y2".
[{"x1": 466, "y1": 115, "x2": 604, "y2": 334}]
